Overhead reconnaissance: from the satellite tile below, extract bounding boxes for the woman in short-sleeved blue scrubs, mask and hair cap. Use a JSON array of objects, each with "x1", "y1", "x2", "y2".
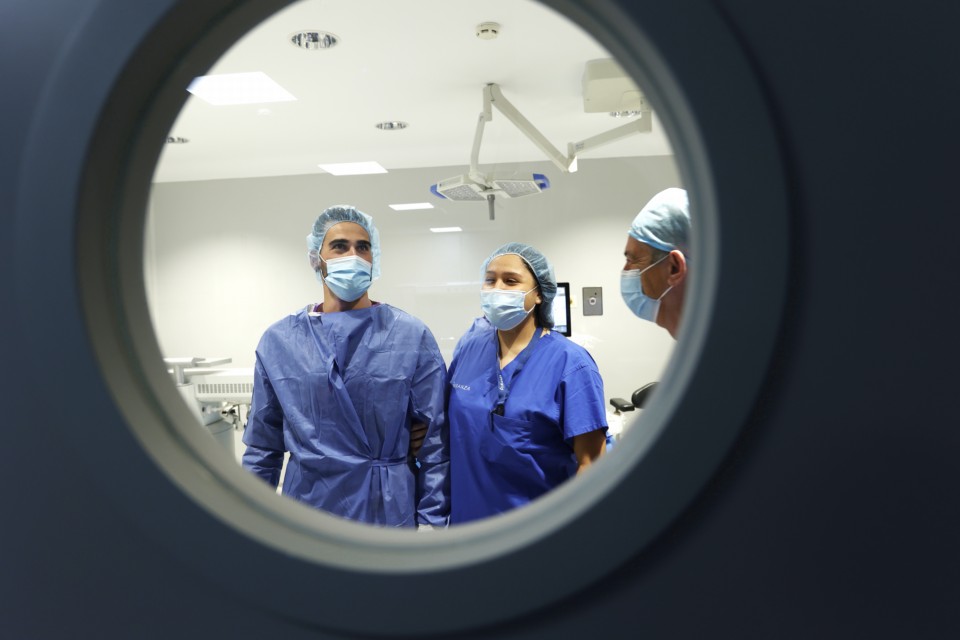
[{"x1": 447, "y1": 242, "x2": 607, "y2": 524}]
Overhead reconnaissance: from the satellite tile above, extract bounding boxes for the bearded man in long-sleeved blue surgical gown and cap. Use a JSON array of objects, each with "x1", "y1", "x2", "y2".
[{"x1": 242, "y1": 205, "x2": 450, "y2": 529}]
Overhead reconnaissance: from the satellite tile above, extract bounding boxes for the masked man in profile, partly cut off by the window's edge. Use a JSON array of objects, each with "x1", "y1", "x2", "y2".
[{"x1": 620, "y1": 187, "x2": 690, "y2": 339}]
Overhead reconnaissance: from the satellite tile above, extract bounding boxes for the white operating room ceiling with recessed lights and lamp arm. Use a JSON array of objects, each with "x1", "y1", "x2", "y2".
[{"x1": 155, "y1": 0, "x2": 672, "y2": 182}]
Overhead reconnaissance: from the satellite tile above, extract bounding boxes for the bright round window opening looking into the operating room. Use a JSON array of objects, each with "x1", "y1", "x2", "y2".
[{"x1": 145, "y1": 0, "x2": 676, "y2": 540}]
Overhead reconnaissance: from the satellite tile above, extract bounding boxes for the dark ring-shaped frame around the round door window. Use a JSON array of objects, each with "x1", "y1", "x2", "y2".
[{"x1": 11, "y1": 0, "x2": 787, "y2": 635}]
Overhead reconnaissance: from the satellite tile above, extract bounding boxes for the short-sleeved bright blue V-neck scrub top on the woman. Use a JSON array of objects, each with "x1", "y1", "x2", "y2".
[{"x1": 447, "y1": 323, "x2": 607, "y2": 523}]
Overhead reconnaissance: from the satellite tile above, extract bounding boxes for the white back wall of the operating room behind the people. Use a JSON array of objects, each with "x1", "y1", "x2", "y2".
[{"x1": 145, "y1": 157, "x2": 680, "y2": 410}]
